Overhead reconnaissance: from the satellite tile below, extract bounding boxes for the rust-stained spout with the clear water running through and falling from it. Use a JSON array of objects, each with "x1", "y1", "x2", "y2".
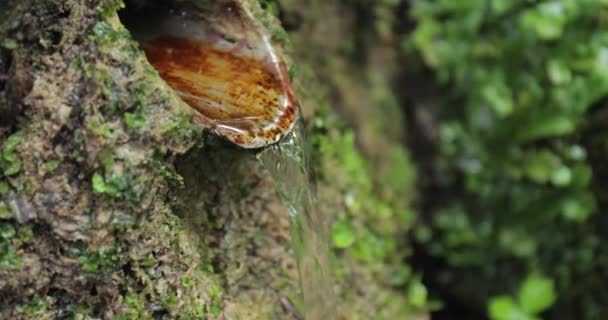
[{"x1": 116, "y1": 0, "x2": 336, "y2": 320}]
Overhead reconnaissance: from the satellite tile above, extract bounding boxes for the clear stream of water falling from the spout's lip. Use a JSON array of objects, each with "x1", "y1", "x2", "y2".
[{"x1": 258, "y1": 121, "x2": 336, "y2": 320}]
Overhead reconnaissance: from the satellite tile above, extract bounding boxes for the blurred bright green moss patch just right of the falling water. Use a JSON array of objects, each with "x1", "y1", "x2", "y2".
[{"x1": 313, "y1": 124, "x2": 435, "y2": 317}]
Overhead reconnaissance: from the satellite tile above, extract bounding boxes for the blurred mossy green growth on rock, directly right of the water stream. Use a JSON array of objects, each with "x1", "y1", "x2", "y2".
[{"x1": 309, "y1": 105, "x2": 438, "y2": 319}]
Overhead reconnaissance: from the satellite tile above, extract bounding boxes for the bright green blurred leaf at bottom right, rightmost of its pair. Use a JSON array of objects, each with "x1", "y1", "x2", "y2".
[{"x1": 518, "y1": 274, "x2": 556, "y2": 314}]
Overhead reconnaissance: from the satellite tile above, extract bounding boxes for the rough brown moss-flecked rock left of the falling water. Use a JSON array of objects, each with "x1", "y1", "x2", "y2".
[{"x1": 0, "y1": 1, "x2": 296, "y2": 319}]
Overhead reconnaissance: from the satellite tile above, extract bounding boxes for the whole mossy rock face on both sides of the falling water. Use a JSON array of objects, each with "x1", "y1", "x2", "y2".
[{"x1": 0, "y1": 0, "x2": 426, "y2": 319}]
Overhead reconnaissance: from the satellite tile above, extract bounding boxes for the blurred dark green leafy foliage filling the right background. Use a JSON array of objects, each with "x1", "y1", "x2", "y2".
[{"x1": 404, "y1": 0, "x2": 608, "y2": 319}]
